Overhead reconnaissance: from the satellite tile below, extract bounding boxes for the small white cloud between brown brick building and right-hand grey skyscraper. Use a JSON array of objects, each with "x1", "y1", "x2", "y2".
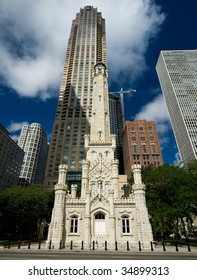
[{"x1": 135, "y1": 94, "x2": 171, "y2": 148}]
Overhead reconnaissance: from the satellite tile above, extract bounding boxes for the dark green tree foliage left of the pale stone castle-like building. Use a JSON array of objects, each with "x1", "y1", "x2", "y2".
[{"x1": 0, "y1": 186, "x2": 53, "y2": 239}]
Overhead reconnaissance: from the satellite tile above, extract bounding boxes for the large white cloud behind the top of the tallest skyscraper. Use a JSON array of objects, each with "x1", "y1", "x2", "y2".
[{"x1": 0, "y1": 0, "x2": 164, "y2": 99}]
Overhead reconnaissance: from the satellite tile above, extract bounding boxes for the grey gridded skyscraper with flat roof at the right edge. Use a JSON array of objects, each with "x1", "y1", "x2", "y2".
[{"x1": 156, "y1": 50, "x2": 197, "y2": 163}]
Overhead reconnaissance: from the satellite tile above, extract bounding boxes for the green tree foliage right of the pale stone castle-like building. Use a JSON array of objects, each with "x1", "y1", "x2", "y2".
[{"x1": 131, "y1": 161, "x2": 197, "y2": 238}]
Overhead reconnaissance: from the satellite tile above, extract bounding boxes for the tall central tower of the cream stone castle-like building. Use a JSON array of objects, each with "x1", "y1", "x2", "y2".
[{"x1": 81, "y1": 62, "x2": 119, "y2": 242}]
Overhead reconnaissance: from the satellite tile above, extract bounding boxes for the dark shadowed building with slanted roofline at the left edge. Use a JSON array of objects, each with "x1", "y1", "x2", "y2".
[{"x1": 0, "y1": 124, "x2": 24, "y2": 188}]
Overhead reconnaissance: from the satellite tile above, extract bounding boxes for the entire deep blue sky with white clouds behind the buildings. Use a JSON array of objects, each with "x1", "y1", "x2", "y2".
[{"x1": 0, "y1": 0, "x2": 197, "y2": 163}]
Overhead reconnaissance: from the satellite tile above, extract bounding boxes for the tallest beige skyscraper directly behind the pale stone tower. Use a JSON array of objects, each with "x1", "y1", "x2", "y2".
[{"x1": 45, "y1": 6, "x2": 107, "y2": 186}]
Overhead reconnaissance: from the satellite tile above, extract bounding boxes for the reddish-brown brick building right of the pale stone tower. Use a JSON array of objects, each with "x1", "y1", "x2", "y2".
[{"x1": 123, "y1": 120, "x2": 163, "y2": 178}]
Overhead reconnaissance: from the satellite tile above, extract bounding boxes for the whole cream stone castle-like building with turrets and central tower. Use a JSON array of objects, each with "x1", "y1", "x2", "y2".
[{"x1": 47, "y1": 62, "x2": 153, "y2": 248}]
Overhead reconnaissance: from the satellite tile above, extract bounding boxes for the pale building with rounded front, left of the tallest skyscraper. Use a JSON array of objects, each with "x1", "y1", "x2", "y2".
[{"x1": 18, "y1": 123, "x2": 48, "y2": 184}]
